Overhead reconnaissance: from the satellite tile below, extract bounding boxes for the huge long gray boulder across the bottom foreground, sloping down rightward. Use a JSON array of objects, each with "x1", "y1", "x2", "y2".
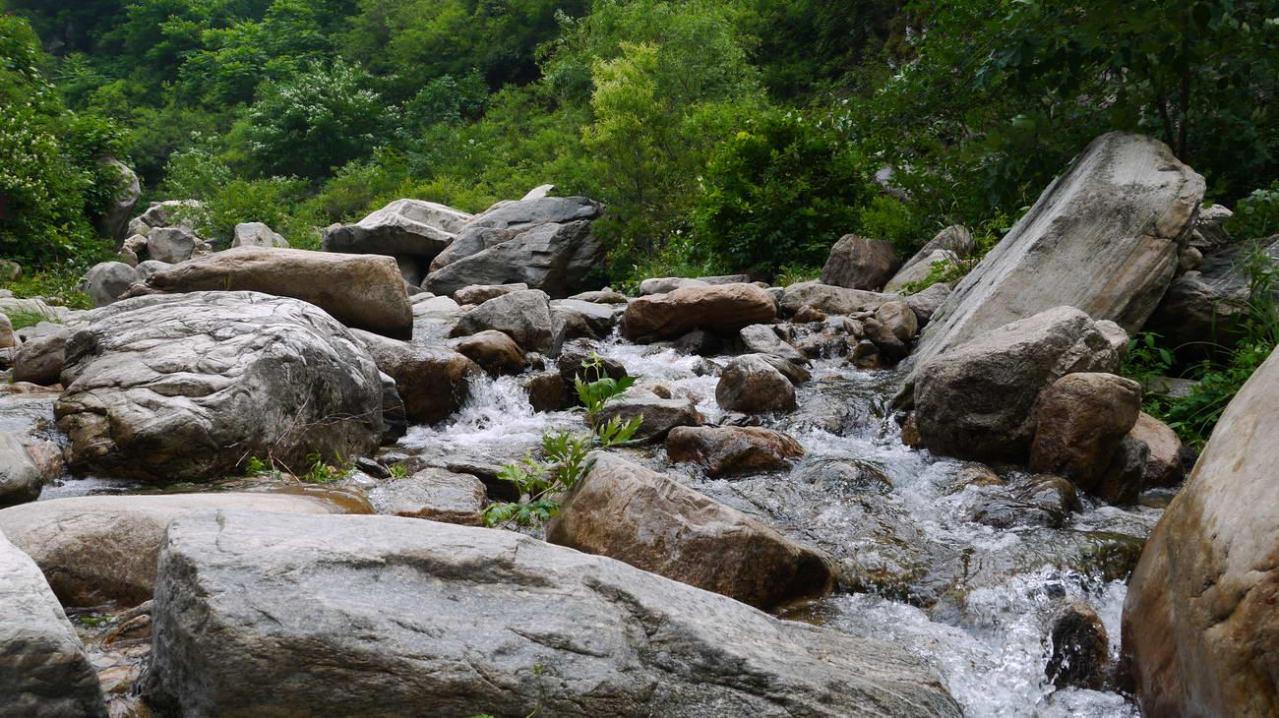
[{"x1": 151, "y1": 512, "x2": 959, "y2": 718}]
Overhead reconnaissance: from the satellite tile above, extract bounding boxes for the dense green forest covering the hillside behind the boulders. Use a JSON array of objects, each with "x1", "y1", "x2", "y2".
[{"x1": 0, "y1": 0, "x2": 1279, "y2": 285}]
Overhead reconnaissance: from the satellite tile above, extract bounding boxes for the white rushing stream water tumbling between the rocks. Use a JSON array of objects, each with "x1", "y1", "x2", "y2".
[{"x1": 399, "y1": 339, "x2": 1157, "y2": 718}]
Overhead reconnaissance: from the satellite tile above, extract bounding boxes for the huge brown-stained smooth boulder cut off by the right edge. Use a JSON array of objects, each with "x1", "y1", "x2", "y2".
[{"x1": 1122, "y1": 352, "x2": 1279, "y2": 718}]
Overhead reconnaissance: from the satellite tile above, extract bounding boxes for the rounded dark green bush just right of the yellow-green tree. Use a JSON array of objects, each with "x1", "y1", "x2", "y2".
[{"x1": 696, "y1": 111, "x2": 868, "y2": 276}]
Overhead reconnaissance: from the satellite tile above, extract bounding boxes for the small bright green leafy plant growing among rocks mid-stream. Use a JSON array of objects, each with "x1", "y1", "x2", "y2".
[{"x1": 483, "y1": 353, "x2": 643, "y2": 527}]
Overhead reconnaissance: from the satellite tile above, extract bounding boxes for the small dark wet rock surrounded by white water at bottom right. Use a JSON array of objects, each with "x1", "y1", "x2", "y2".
[{"x1": 1044, "y1": 602, "x2": 1110, "y2": 691}]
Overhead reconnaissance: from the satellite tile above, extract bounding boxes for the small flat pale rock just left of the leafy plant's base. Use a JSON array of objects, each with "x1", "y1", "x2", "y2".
[{"x1": 368, "y1": 468, "x2": 486, "y2": 526}]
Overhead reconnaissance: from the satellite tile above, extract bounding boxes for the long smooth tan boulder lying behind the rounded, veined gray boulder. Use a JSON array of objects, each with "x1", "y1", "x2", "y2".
[{"x1": 132, "y1": 247, "x2": 413, "y2": 339}]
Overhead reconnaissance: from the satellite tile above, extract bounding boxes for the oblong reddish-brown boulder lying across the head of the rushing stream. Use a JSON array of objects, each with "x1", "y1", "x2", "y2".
[{"x1": 622, "y1": 284, "x2": 778, "y2": 340}]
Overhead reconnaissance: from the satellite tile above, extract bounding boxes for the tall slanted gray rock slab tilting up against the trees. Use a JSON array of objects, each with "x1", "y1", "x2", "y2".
[{"x1": 916, "y1": 132, "x2": 1204, "y2": 378}]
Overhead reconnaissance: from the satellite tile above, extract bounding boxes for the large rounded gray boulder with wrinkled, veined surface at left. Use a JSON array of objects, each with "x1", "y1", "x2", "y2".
[{"x1": 55, "y1": 291, "x2": 382, "y2": 481}]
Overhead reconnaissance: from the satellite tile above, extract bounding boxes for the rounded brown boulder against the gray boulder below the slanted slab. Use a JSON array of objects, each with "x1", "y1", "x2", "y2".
[{"x1": 1030, "y1": 371, "x2": 1141, "y2": 493}]
